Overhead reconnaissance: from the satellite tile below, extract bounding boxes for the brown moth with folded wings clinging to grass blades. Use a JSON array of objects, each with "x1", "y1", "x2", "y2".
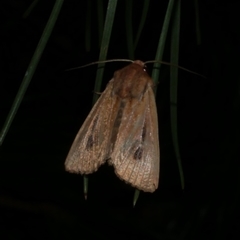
[{"x1": 65, "y1": 60, "x2": 160, "y2": 192}]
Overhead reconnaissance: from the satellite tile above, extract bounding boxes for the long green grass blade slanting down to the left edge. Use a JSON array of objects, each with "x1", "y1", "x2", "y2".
[{"x1": 0, "y1": 0, "x2": 63, "y2": 145}]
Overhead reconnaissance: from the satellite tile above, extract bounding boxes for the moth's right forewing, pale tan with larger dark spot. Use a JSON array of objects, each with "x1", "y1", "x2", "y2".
[{"x1": 109, "y1": 85, "x2": 160, "y2": 192}]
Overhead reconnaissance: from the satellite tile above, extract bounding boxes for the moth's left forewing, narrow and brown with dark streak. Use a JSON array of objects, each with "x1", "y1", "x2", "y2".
[{"x1": 65, "y1": 80, "x2": 114, "y2": 174}]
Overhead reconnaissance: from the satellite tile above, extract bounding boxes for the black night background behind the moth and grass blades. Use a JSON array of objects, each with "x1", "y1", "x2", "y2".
[{"x1": 0, "y1": 0, "x2": 240, "y2": 240}]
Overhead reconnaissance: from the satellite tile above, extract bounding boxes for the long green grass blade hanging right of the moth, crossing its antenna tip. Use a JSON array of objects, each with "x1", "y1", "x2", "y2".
[{"x1": 170, "y1": 1, "x2": 184, "y2": 189}]
